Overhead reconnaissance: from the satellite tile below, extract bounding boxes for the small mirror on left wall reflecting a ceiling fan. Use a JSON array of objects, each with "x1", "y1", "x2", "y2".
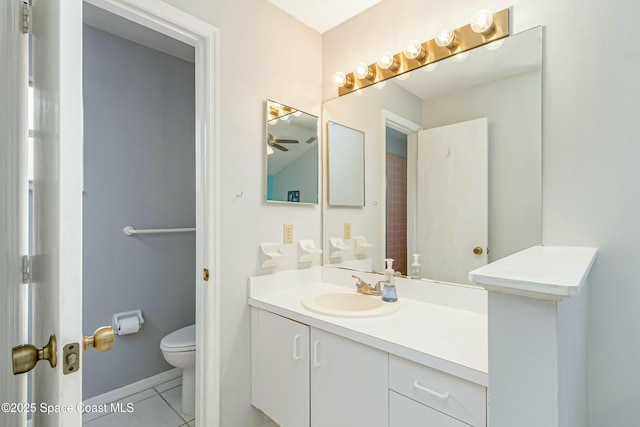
[{"x1": 265, "y1": 100, "x2": 319, "y2": 204}]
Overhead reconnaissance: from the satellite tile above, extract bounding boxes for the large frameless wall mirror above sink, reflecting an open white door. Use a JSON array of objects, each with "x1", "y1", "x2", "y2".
[{"x1": 322, "y1": 27, "x2": 542, "y2": 284}]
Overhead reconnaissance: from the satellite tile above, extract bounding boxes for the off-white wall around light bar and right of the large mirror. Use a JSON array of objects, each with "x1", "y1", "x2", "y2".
[{"x1": 322, "y1": 0, "x2": 640, "y2": 427}]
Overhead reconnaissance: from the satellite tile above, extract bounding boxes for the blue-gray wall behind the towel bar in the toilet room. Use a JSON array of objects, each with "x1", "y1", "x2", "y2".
[{"x1": 83, "y1": 26, "x2": 195, "y2": 398}]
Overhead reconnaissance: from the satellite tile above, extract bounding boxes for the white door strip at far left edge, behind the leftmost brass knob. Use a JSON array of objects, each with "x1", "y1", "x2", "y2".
[{"x1": 0, "y1": 0, "x2": 28, "y2": 427}]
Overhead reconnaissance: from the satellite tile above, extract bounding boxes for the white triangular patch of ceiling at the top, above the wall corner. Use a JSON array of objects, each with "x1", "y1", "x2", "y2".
[{"x1": 267, "y1": 0, "x2": 381, "y2": 34}]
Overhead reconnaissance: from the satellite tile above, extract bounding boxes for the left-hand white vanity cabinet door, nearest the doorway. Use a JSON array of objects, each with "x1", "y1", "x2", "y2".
[{"x1": 251, "y1": 308, "x2": 309, "y2": 427}]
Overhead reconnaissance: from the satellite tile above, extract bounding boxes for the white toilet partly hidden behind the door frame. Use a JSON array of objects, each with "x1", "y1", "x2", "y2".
[{"x1": 160, "y1": 325, "x2": 196, "y2": 416}]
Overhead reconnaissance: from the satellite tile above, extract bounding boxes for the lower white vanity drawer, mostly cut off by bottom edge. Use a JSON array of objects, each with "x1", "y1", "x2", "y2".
[{"x1": 389, "y1": 391, "x2": 469, "y2": 427}]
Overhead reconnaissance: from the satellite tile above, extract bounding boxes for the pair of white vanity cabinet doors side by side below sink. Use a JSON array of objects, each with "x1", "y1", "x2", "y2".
[{"x1": 251, "y1": 308, "x2": 389, "y2": 427}]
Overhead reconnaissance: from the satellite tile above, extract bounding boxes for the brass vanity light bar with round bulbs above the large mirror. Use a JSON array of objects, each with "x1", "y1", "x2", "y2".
[{"x1": 333, "y1": 9, "x2": 509, "y2": 96}]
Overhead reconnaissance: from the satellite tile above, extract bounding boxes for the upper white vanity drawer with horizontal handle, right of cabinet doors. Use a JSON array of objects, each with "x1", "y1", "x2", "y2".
[{"x1": 389, "y1": 355, "x2": 487, "y2": 427}]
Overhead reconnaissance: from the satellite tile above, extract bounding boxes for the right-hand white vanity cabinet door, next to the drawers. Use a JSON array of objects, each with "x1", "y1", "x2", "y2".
[{"x1": 311, "y1": 328, "x2": 389, "y2": 427}]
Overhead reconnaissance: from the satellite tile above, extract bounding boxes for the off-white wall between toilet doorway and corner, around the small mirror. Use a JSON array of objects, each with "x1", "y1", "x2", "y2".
[{"x1": 158, "y1": 0, "x2": 322, "y2": 427}]
